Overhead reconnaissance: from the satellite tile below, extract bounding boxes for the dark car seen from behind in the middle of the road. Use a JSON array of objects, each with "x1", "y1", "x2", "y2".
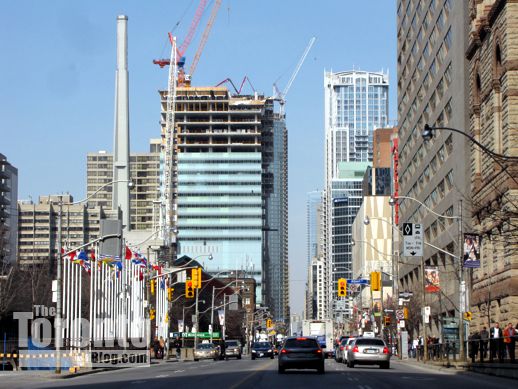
[{"x1": 278, "y1": 337, "x2": 325, "y2": 374}]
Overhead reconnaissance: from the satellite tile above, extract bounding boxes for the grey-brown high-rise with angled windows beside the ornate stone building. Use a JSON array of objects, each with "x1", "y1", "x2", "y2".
[{"x1": 397, "y1": 0, "x2": 470, "y2": 337}]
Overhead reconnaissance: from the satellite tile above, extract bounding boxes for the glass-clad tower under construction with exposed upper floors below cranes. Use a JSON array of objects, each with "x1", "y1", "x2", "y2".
[{"x1": 160, "y1": 87, "x2": 289, "y2": 321}]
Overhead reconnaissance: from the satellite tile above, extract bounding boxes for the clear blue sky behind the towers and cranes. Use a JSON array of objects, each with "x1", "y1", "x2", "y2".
[{"x1": 0, "y1": 0, "x2": 396, "y2": 313}]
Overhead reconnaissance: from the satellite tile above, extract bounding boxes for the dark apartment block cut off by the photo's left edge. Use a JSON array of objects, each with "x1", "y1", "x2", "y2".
[{"x1": 0, "y1": 154, "x2": 18, "y2": 266}]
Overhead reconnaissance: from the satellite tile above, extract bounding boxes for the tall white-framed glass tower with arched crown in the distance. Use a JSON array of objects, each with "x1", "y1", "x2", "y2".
[{"x1": 323, "y1": 70, "x2": 389, "y2": 317}]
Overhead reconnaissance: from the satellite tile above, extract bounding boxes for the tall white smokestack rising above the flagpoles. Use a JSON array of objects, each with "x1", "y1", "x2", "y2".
[{"x1": 112, "y1": 15, "x2": 131, "y2": 231}]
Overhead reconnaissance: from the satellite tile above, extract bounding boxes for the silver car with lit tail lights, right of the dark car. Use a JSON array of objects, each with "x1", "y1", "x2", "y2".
[{"x1": 347, "y1": 337, "x2": 390, "y2": 369}]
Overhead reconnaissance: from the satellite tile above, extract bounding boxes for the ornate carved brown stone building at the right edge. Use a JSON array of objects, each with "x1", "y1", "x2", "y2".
[{"x1": 466, "y1": 0, "x2": 518, "y2": 330}]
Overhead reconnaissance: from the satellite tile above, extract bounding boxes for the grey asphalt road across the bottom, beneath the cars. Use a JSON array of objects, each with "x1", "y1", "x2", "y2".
[{"x1": 0, "y1": 357, "x2": 516, "y2": 389}]
